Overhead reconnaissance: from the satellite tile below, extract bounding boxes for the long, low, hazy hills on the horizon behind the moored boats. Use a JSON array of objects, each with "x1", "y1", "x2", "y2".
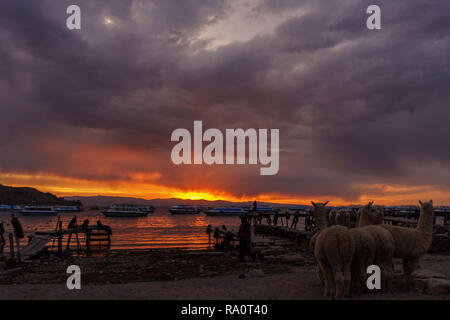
[{"x1": 65, "y1": 195, "x2": 292, "y2": 207}]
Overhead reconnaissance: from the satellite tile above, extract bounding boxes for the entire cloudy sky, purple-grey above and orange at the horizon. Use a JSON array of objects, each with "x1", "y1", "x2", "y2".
[{"x1": 0, "y1": 0, "x2": 450, "y2": 203}]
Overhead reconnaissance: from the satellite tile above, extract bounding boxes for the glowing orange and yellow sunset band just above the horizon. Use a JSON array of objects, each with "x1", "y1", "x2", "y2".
[{"x1": 2, "y1": 174, "x2": 450, "y2": 205}]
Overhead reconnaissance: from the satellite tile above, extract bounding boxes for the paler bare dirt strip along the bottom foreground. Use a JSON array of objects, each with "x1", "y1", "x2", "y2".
[{"x1": 0, "y1": 256, "x2": 450, "y2": 300}]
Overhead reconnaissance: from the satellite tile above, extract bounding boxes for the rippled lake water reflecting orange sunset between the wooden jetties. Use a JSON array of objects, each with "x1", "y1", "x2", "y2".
[{"x1": 0, "y1": 208, "x2": 246, "y2": 249}]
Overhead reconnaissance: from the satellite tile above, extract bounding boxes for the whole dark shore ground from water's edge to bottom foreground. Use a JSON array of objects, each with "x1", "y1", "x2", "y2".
[{"x1": 0, "y1": 247, "x2": 450, "y2": 300}]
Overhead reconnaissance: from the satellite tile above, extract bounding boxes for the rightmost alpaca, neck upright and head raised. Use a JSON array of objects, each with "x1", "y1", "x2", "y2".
[{"x1": 383, "y1": 200, "x2": 434, "y2": 284}]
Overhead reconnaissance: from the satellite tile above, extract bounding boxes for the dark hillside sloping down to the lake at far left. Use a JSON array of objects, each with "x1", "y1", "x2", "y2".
[{"x1": 0, "y1": 184, "x2": 82, "y2": 206}]
